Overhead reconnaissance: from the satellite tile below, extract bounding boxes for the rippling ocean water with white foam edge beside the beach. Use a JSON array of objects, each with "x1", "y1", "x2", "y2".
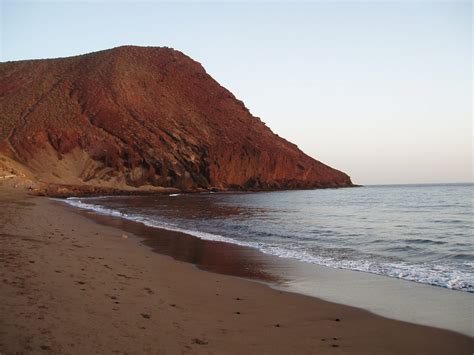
[{"x1": 65, "y1": 184, "x2": 474, "y2": 292}]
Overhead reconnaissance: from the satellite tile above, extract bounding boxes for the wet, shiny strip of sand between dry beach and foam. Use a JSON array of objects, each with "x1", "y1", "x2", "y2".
[{"x1": 56, "y1": 200, "x2": 474, "y2": 337}]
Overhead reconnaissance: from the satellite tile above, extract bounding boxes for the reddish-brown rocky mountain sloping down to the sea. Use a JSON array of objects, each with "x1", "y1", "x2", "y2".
[{"x1": 0, "y1": 46, "x2": 352, "y2": 195}]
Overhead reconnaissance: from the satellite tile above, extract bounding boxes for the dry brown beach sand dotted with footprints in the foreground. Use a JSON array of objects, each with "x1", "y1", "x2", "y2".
[{"x1": 0, "y1": 184, "x2": 474, "y2": 354}]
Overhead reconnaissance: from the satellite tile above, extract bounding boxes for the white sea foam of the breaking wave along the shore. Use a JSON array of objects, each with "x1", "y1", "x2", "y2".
[{"x1": 59, "y1": 199, "x2": 474, "y2": 292}]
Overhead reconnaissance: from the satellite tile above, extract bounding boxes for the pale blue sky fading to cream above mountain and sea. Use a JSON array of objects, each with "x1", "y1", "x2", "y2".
[{"x1": 0, "y1": 0, "x2": 473, "y2": 184}]
